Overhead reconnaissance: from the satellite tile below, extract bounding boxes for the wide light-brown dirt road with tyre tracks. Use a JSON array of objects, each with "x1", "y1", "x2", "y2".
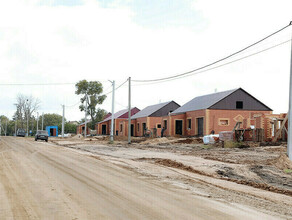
[{"x1": 0, "y1": 137, "x2": 286, "y2": 219}]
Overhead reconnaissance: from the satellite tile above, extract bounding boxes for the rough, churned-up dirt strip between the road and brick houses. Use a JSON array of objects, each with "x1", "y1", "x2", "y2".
[{"x1": 50, "y1": 136, "x2": 292, "y2": 196}]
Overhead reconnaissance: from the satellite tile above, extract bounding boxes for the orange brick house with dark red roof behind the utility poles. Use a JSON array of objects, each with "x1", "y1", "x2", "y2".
[{"x1": 97, "y1": 107, "x2": 140, "y2": 135}]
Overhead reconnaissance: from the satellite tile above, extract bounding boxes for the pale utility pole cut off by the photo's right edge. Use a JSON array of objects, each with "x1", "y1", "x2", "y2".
[{"x1": 287, "y1": 21, "x2": 292, "y2": 160}]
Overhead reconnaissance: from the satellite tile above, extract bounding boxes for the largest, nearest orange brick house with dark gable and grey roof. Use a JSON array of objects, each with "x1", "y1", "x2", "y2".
[{"x1": 168, "y1": 88, "x2": 273, "y2": 136}]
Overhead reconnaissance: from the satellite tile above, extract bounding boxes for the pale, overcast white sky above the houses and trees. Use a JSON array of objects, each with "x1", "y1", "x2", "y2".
[{"x1": 0, "y1": 0, "x2": 292, "y2": 121}]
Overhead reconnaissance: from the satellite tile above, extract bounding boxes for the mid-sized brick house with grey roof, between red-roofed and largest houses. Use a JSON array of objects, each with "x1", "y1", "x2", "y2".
[{"x1": 131, "y1": 101, "x2": 180, "y2": 137}]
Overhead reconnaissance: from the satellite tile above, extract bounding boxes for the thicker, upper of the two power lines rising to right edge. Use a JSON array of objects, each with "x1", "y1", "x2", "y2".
[{"x1": 132, "y1": 22, "x2": 292, "y2": 82}]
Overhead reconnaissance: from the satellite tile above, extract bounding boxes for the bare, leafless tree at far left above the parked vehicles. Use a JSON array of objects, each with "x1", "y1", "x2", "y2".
[{"x1": 14, "y1": 94, "x2": 41, "y2": 131}]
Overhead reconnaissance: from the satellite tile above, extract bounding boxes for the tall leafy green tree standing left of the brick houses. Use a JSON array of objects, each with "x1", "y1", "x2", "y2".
[{"x1": 75, "y1": 80, "x2": 106, "y2": 129}]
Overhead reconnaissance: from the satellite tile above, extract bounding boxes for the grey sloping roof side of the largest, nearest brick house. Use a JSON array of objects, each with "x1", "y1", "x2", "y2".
[{"x1": 172, "y1": 89, "x2": 238, "y2": 114}]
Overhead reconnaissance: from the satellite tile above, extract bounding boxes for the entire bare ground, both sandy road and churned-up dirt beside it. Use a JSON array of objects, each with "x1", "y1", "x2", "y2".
[{"x1": 0, "y1": 136, "x2": 292, "y2": 219}]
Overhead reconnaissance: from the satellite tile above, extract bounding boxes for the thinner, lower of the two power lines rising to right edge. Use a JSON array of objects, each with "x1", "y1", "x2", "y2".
[{"x1": 132, "y1": 39, "x2": 292, "y2": 86}]
